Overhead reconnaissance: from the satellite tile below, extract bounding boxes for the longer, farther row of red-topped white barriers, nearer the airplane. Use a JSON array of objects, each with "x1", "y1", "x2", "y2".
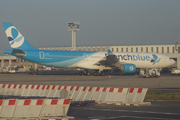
[{"x1": 0, "y1": 84, "x2": 148, "y2": 105}]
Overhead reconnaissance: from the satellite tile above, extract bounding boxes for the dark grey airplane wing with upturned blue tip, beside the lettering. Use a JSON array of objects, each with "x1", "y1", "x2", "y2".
[{"x1": 95, "y1": 49, "x2": 120, "y2": 67}]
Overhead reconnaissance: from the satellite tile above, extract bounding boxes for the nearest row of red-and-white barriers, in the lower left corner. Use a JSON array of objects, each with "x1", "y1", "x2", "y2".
[{"x1": 0, "y1": 99, "x2": 70, "y2": 119}]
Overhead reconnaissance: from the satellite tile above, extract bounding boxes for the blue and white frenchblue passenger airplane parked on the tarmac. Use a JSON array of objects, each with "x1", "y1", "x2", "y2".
[{"x1": 2, "y1": 23, "x2": 175, "y2": 76}]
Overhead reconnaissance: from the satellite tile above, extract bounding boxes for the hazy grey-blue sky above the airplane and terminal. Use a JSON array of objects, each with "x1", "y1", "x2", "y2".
[{"x1": 0, "y1": 0, "x2": 180, "y2": 54}]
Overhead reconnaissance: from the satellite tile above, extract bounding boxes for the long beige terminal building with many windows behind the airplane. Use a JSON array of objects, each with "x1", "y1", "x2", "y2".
[{"x1": 0, "y1": 43, "x2": 180, "y2": 70}]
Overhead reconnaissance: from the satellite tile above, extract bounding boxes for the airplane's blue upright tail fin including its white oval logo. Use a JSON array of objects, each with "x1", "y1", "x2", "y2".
[{"x1": 2, "y1": 23, "x2": 38, "y2": 50}]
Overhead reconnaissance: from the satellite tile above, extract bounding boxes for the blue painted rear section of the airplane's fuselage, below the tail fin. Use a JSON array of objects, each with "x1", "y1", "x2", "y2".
[{"x1": 13, "y1": 50, "x2": 97, "y2": 67}]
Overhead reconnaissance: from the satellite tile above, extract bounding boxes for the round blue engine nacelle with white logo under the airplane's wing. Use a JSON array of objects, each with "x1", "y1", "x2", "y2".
[{"x1": 121, "y1": 64, "x2": 136, "y2": 73}]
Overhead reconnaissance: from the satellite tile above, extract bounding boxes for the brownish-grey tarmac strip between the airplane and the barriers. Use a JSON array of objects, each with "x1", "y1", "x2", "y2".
[{"x1": 0, "y1": 73, "x2": 180, "y2": 90}]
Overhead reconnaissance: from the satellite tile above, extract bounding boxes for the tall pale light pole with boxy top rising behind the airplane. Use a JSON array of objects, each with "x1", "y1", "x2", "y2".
[{"x1": 67, "y1": 22, "x2": 80, "y2": 50}]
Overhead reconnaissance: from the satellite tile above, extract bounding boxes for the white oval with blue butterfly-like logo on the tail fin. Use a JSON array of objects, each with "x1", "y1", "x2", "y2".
[{"x1": 5, "y1": 26, "x2": 24, "y2": 48}]
